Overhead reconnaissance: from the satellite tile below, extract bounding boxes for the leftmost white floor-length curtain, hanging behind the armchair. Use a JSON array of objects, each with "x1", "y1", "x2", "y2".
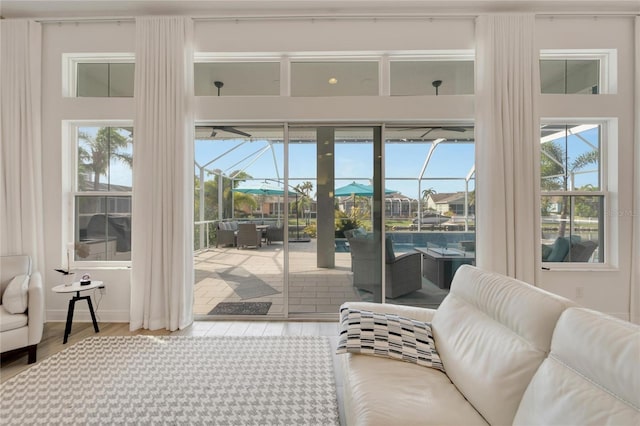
[{"x1": 0, "y1": 20, "x2": 44, "y2": 272}]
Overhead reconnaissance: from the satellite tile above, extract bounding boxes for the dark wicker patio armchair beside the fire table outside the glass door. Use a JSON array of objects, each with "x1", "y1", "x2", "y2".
[{"x1": 345, "y1": 233, "x2": 422, "y2": 299}]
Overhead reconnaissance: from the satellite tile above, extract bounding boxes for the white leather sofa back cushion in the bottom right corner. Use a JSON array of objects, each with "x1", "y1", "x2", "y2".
[{"x1": 514, "y1": 308, "x2": 640, "y2": 425}]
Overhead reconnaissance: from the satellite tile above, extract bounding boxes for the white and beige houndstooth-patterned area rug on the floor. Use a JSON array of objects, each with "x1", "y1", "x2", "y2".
[{"x1": 0, "y1": 336, "x2": 339, "y2": 425}]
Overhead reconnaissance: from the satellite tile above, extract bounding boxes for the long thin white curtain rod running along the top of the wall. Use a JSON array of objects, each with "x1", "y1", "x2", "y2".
[{"x1": 33, "y1": 11, "x2": 640, "y2": 24}]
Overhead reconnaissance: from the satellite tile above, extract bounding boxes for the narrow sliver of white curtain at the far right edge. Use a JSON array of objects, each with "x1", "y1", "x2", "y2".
[{"x1": 629, "y1": 16, "x2": 640, "y2": 324}]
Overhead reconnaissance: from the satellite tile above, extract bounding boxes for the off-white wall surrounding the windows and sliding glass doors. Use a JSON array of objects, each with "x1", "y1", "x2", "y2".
[{"x1": 42, "y1": 18, "x2": 638, "y2": 321}]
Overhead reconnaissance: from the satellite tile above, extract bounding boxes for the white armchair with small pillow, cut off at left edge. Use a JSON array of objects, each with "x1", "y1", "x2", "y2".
[{"x1": 0, "y1": 256, "x2": 44, "y2": 364}]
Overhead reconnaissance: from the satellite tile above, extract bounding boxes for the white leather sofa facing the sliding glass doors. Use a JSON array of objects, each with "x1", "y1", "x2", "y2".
[{"x1": 342, "y1": 265, "x2": 640, "y2": 426}]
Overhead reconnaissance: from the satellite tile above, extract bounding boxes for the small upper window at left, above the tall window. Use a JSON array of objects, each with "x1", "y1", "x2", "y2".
[{"x1": 62, "y1": 53, "x2": 135, "y2": 98}]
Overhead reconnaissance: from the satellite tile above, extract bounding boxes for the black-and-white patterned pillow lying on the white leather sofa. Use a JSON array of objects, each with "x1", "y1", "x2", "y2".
[{"x1": 336, "y1": 305, "x2": 444, "y2": 371}]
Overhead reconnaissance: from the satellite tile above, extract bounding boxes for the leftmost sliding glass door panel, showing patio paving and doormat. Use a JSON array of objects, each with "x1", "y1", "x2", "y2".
[{"x1": 194, "y1": 125, "x2": 287, "y2": 319}]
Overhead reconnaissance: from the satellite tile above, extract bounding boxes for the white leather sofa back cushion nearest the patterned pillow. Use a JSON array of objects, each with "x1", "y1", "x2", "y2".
[{"x1": 432, "y1": 265, "x2": 574, "y2": 425}]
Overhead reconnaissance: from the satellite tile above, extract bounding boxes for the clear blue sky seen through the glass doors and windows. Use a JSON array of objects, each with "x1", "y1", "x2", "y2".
[{"x1": 81, "y1": 122, "x2": 598, "y2": 198}]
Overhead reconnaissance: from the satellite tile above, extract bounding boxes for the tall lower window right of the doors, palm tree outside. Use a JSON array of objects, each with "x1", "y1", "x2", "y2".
[{"x1": 540, "y1": 123, "x2": 607, "y2": 263}]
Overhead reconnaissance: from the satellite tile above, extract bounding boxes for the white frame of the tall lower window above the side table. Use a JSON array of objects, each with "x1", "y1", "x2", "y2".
[{"x1": 62, "y1": 120, "x2": 134, "y2": 269}]
